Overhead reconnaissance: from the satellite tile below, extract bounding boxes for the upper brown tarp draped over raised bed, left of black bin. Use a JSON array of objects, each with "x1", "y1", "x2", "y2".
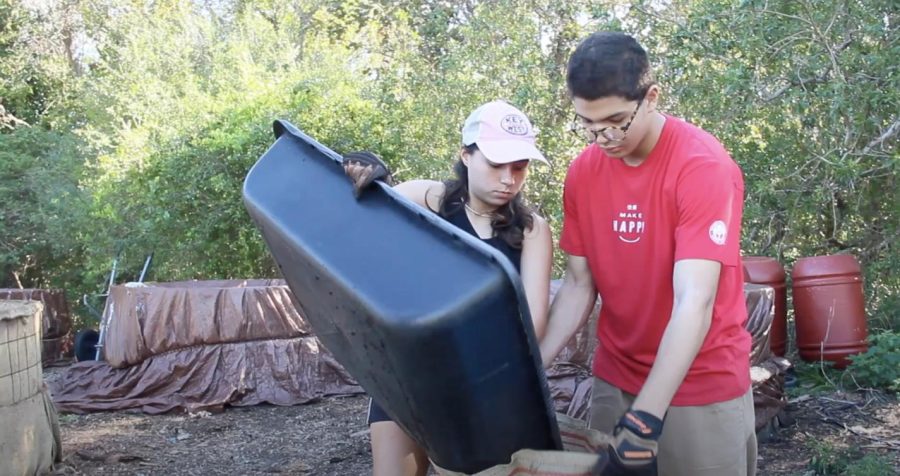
[{"x1": 103, "y1": 279, "x2": 312, "y2": 368}]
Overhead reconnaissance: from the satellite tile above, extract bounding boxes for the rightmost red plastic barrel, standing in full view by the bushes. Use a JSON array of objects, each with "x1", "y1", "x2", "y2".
[{"x1": 791, "y1": 255, "x2": 868, "y2": 368}]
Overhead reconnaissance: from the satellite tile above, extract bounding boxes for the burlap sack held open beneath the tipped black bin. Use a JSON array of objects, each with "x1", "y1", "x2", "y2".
[{"x1": 434, "y1": 413, "x2": 610, "y2": 476}]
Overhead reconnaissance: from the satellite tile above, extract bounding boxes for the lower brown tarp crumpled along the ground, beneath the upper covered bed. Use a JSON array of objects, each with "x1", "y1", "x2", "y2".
[{"x1": 50, "y1": 337, "x2": 362, "y2": 414}]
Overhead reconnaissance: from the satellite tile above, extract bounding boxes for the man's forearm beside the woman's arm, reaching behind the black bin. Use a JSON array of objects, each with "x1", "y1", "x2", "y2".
[{"x1": 541, "y1": 281, "x2": 597, "y2": 367}]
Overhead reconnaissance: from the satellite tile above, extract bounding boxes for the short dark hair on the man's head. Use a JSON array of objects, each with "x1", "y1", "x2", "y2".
[{"x1": 566, "y1": 31, "x2": 654, "y2": 101}]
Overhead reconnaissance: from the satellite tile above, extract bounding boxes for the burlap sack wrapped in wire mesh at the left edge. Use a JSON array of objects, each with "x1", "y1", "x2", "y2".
[{"x1": 0, "y1": 301, "x2": 61, "y2": 476}]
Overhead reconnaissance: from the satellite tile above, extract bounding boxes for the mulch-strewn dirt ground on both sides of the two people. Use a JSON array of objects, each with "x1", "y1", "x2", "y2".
[{"x1": 45, "y1": 362, "x2": 900, "y2": 476}]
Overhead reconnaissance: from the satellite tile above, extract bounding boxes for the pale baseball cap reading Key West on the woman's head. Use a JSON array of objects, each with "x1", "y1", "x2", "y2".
[{"x1": 462, "y1": 100, "x2": 550, "y2": 165}]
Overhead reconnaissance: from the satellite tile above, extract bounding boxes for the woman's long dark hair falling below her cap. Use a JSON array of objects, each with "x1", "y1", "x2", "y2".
[{"x1": 434, "y1": 144, "x2": 534, "y2": 249}]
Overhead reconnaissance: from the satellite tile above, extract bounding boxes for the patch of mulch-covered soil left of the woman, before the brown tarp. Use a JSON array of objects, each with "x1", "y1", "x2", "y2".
[{"x1": 55, "y1": 396, "x2": 372, "y2": 476}]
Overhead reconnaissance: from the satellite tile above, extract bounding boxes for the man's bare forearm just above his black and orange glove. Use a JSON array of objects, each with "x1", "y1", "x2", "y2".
[{"x1": 632, "y1": 302, "x2": 712, "y2": 418}]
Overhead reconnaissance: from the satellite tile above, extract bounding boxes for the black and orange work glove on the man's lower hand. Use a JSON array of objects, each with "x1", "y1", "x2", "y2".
[{"x1": 593, "y1": 410, "x2": 663, "y2": 476}]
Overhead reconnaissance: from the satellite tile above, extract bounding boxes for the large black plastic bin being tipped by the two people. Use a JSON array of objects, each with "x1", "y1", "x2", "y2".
[{"x1": 244, "y1": 121, "x2": 562, "y2": 473}]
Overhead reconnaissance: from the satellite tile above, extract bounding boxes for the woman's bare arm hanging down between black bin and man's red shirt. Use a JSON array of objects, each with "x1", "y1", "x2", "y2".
[{"x1": 519, "y1": 214, "x2": 553, "y2": 342}]
